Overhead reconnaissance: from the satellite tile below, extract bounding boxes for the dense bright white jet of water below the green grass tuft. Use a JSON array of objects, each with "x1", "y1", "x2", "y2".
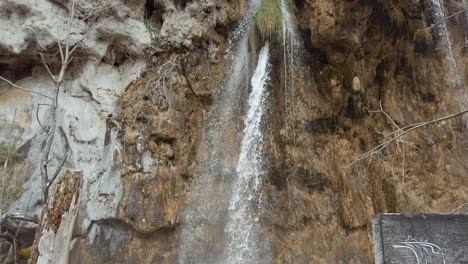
[{"x1": 225, "y1": 42, "x2": 271, "y2": 264}]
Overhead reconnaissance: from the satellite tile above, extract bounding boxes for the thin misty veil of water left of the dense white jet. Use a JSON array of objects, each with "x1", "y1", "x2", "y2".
[{"x1": 178, "y1": 0, "x2": 259, "y2": 264}]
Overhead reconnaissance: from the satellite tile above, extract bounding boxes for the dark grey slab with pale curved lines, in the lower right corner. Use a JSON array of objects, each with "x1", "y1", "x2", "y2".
[{"x1": 372, "y1": 214, "x2": 468, "y2": 264}]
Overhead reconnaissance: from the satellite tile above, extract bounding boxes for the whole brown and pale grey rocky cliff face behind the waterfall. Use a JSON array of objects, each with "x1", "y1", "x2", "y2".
[{"x1": 0, "y1": 0, "x2": 468, "y2": 263}]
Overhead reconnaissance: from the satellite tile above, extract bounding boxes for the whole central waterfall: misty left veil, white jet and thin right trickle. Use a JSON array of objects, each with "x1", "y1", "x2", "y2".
[{"x1": 178, "y1": 0, "x2": 298, "y2": 264}]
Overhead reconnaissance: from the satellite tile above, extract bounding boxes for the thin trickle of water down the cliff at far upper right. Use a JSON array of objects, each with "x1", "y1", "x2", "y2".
[{"x1": 429, "y1": 0, "x2": 460, "y2": 89}]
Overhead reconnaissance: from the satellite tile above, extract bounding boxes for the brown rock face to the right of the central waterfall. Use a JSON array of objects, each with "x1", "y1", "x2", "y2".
[{"x1": 264, "y1": 1, "x2": 467, "y2": 263}]
